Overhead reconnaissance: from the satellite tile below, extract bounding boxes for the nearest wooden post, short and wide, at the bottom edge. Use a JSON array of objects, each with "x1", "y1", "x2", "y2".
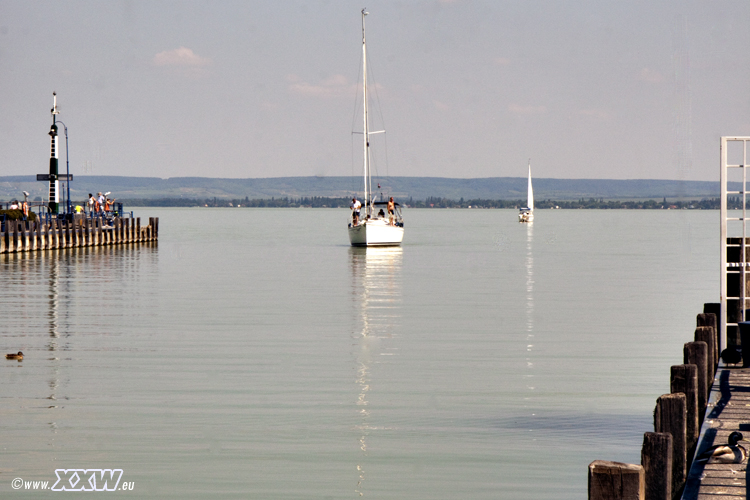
[{"x1": 589, "y1": 460, "x2": 646, "y2": 500}]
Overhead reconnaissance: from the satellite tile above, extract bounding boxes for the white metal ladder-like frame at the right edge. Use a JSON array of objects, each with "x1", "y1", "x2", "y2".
[{"x1": 719, "y1": 137, "x2": 750, "y2": 350}]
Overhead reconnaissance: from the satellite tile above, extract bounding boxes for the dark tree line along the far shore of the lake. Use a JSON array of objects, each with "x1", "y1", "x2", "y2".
[{"x1": 86, "y1": 196, "x2": 750, "y2": 210}]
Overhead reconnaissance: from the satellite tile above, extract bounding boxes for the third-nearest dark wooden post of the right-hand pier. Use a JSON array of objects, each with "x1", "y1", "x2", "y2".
[{"x1": 654, "y1": 393, "x2": 687, "y2": 492}]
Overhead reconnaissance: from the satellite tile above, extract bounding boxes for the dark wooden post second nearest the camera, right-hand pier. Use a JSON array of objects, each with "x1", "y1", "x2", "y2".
[{"x1": 641, "y1": 432, "x2": 672, "y2": 500}]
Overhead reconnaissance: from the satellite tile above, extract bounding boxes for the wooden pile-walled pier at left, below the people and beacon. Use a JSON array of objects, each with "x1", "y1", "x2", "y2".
[{"x1": 0, "y1": 217, "x2": 159, "y2": 254}]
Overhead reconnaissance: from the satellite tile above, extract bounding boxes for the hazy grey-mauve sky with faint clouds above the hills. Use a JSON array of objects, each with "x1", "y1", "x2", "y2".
[{"x1": 0, "y1": 0, "x2": 750, "y2": 180}]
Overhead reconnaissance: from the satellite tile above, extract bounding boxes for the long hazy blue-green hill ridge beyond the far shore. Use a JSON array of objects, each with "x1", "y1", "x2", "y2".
[{"x1": 0, "y1": 175, "x2": 719, "y2": 201}]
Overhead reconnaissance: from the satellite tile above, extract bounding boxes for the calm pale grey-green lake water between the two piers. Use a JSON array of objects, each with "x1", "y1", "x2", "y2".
[{"x1": 0, "y1": 208, "x2": 719, "y2": 499}]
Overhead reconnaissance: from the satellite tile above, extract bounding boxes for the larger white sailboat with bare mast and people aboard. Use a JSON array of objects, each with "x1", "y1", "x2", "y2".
[{"x1": 349, "y1": 9, "x2": 404, "y2": 247}]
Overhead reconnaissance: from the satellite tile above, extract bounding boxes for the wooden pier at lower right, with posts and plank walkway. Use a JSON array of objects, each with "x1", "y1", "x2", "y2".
[{"x1": 588, "y1": 304, "x2": 724, "y2": 500}]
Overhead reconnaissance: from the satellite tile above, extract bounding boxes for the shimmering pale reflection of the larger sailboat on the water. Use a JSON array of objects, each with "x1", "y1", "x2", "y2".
[{"x1": 349, "y1": 247, "x2": 403, "y2": 495}]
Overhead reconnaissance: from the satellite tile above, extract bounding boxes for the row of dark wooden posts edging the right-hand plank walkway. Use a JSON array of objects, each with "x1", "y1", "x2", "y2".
[{"x1": 588, "y1": 304, "x2": 719, "y2": 500}]
